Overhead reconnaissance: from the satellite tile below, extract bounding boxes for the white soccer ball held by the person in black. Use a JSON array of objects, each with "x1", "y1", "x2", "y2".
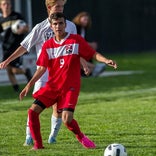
[{"x1": 11, "y1": 20, "x2": 26, "y2": 34}]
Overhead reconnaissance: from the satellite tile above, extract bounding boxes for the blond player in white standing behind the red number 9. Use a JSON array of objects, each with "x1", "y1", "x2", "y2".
[{"x1": 0, "y1": 0, "x2": 88, "y2": 146}]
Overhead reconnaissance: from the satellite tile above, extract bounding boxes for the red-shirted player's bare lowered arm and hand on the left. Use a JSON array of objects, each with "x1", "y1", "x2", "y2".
[{"x1": 19, "y1": 66, "x2": 47, "y2": 100}]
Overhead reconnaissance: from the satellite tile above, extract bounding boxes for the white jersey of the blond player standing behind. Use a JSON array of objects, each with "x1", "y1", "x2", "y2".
[{"x1": 21, "y1": 18, "x2": 77, "y2": 82}]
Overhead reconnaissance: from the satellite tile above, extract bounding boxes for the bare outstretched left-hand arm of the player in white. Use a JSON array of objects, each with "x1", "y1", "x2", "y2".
[{"x1": 0, "y1": 46, "x2": 27, "y2": 69}]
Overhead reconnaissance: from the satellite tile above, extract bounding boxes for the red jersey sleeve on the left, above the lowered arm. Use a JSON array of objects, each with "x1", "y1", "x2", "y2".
[{"x1": 36, "y1": 42, "x2": 49, "y2": 68}]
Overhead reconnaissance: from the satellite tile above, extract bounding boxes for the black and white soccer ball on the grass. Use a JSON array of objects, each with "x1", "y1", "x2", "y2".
[{"x1": 104, "y1": 143, "x2": 127, "y2": 156}]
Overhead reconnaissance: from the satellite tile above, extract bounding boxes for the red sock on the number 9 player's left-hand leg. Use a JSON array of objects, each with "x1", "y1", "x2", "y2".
[{"x1": 28, "y1": 109, "x2": 43, "y2": 148}]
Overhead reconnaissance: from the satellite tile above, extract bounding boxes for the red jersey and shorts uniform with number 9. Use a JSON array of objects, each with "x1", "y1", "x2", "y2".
[{"x1": 33, "y1": 34, "x2": 96, "y2": 110}]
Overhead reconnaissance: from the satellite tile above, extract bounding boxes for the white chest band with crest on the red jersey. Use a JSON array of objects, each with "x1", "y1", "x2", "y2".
[{"x1": 47, "y1": 43, "x2": 79, "y2": 59}]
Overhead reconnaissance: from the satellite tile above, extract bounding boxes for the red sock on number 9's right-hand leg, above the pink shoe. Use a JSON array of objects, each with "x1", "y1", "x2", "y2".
[{"x1": 66, "y1": 119, "x2": 84, "y2": 139}]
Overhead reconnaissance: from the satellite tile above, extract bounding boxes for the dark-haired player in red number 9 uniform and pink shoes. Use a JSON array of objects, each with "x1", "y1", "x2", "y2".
[{"x1": 19, "y1": 13, "x2": 117, "y2": 150}]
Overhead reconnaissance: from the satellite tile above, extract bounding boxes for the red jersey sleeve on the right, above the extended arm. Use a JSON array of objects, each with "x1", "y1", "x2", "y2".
[{"x1": 77, "y1": 35, "x2": 96, "y2": 60}]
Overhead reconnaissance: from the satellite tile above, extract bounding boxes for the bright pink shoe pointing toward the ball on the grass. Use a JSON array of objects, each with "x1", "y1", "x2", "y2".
[{"x1": 76, "y1": 135, "x2": 96, "y2": 148}]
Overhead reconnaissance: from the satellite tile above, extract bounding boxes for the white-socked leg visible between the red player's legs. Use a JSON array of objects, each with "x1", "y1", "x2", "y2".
[{"x1": 48, "y1": 104, "x2": 62, "y2": 144}]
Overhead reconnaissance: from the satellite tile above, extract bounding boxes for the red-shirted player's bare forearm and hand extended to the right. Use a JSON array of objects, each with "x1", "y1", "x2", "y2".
[{"x1": 93, "y1": 52, "x2": 117, "y2": 69}]
